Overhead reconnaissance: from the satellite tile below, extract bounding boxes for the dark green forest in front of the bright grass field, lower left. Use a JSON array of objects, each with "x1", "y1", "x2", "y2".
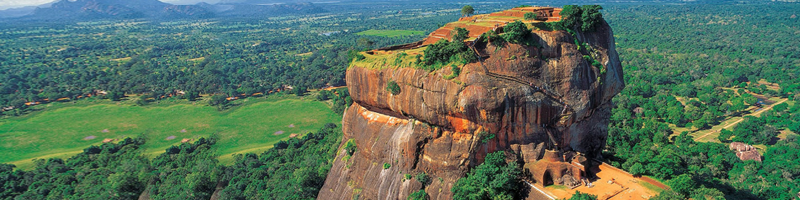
[{"x1": 0, "y1": 124, "x2": 342, "y2": 199}]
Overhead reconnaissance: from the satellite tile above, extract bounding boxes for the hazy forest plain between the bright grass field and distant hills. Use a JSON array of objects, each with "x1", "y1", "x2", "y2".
[{"x1": 0, "y1": 4, "x2": 458, "y2": 115}]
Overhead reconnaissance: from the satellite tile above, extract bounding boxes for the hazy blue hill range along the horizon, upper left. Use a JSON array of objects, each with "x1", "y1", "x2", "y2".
[{"x1": 0, "y1": 0, "x2": 326, "y2": 21}]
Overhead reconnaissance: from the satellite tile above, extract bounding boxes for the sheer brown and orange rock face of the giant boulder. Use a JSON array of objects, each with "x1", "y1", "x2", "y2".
[{"x1": 319, "y1": 18, "x2": 624, "y2": 199}]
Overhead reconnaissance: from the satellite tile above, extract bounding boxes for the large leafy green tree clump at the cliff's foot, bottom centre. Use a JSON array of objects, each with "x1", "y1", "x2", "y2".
[{"x1": 450, "y1": 151, "x2": 524, "y2": 199}]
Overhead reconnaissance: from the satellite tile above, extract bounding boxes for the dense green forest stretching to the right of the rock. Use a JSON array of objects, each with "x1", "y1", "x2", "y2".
[{"x1": 605, "y1": 4, "x2": 800, "y2": 199}]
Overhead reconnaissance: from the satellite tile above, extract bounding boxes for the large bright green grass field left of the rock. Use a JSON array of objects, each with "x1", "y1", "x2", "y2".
[{"x1": 0, "y1": 99, "x2": 341, "y2": 169}]
